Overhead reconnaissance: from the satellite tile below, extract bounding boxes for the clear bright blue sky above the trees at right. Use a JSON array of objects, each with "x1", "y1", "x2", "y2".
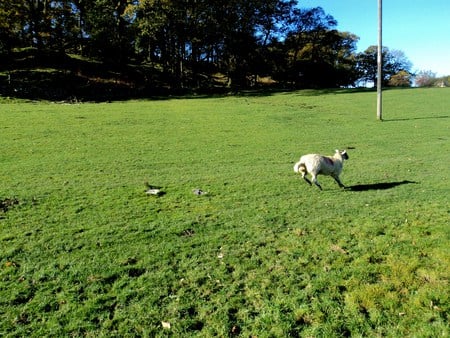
[{"x1": 299, "y1": 0, "x2": 450, "y2": 76}]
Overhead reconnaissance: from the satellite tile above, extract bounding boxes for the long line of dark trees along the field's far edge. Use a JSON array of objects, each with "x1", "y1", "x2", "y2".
[{"x1": 0, "y1": 0, "x2": 411, "y2": 95}]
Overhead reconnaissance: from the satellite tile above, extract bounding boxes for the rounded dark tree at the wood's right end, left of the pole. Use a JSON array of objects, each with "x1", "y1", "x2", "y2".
[{"x1": 285, "y1": 7, "x2": 358, "y2": 87}]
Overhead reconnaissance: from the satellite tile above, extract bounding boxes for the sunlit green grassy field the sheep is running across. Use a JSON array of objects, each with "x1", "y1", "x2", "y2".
[{"x1": 0, "y1": 88, "x2": 450, "y2": 337}]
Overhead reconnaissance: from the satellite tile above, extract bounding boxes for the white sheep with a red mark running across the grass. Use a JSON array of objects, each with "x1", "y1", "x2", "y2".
[{"x1": 294, "y1": 149, "x2": 349, "y2": 190}]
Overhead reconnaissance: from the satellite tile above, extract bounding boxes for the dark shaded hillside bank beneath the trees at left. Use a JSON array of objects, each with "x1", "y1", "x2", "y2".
[{"x1": 0, "y1": 48, "x2": 236, "y2": 102}]
